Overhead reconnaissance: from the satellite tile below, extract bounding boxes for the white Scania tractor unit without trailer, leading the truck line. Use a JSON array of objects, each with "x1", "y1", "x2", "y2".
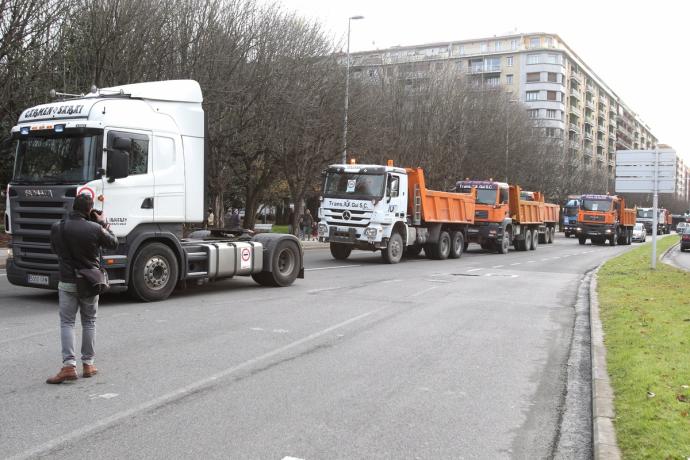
[{"x1": 5, "y1": 80, "x2": 304, "y2": 301}]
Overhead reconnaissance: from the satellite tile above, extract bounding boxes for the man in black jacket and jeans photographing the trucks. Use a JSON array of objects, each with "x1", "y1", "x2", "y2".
[{"x1": 46, "y1": 194, "x2": 117, "y2": 383}]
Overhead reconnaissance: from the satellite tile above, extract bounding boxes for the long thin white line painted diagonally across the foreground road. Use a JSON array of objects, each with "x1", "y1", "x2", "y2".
[{"x1": 10, "y1": 307, "x2": 386, "y2": 459}]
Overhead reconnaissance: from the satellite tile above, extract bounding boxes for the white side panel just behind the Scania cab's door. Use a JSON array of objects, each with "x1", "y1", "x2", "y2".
[{"x1": 153, "y1": 135, "x2": 186, "y2": 222}]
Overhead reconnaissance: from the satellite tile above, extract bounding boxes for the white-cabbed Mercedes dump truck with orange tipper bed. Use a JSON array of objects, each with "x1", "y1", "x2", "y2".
[{"x1": 318, "y1": 161, "x2": 475, "y2": 264}]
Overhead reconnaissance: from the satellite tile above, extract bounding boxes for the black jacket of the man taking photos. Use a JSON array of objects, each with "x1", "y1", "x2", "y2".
[{"x1": 50, "y1": 211, "x2": 117, "y2": 283}]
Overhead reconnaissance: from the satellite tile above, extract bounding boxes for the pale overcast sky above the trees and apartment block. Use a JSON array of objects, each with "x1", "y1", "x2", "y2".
[{"x1": 277, "y1": 0, "x2": 690, "y2": 159}]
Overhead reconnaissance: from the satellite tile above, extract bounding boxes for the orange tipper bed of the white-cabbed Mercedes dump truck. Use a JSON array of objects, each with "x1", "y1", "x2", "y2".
[{"x1": 406, "y1": 168, "x2": 477, "y2": 224}]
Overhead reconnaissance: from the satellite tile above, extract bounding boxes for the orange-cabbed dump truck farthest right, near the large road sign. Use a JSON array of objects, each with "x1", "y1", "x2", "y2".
[{"x1": 576, "y1": 195, "x2": 636, "y2": 246}]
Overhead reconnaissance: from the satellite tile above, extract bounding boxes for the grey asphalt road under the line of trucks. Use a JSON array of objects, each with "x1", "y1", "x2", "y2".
[{"x1": 0, "y1": 236, "x2": 628, "y2": 459}]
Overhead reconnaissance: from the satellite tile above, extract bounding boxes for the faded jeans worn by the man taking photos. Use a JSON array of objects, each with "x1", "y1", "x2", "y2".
[{"x1": 58, "y1": 289, "x2": 98, "y2": 366}]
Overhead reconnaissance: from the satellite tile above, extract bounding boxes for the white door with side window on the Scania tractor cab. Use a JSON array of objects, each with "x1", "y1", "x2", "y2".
[{"x1": 103, "y1": 129, "x2": 156, "y2": 236}]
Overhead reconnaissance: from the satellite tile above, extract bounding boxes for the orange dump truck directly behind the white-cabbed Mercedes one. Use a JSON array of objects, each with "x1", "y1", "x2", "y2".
[{"x1": 455, "y1": 180, "x2": 559, "y2": 254}]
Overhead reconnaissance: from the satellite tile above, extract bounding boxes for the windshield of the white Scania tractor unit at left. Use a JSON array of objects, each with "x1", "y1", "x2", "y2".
[{"x1": 12, "y1": 134, "x2": 103, "y2": 184}]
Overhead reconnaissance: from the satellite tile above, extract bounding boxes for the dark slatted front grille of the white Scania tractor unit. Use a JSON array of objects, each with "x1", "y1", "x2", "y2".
[{"x1": 9, "y1": 185, "x2": 77, "y2": 271}]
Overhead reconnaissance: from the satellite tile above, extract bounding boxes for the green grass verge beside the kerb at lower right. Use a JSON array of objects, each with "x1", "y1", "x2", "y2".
[{"x1": 598, "y1": 236, "x2": 690, "y2": 460}]
